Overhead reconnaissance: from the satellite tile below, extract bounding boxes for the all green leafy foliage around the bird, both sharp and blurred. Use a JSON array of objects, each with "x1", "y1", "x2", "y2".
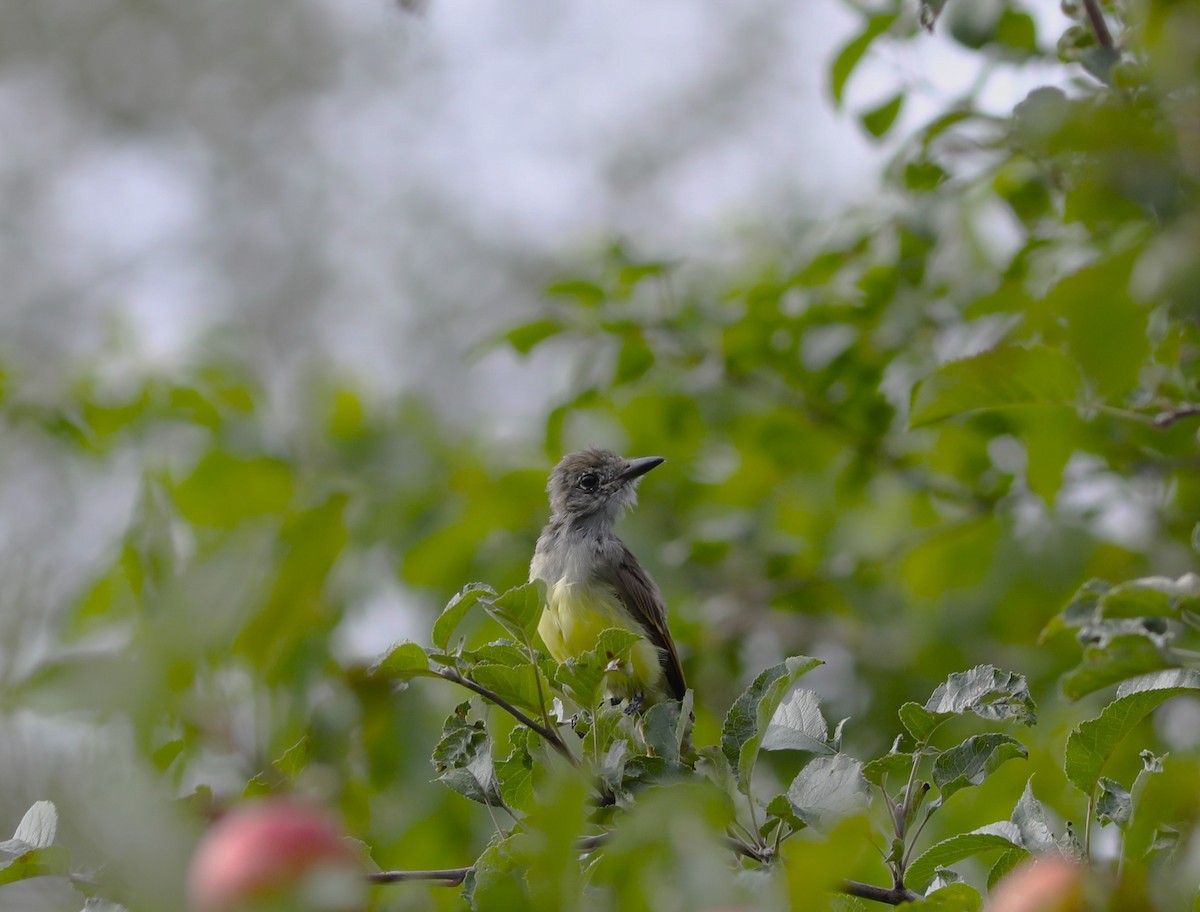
[{"x1": 0, "y1": 0, "x2": 1200, "y2": 912}]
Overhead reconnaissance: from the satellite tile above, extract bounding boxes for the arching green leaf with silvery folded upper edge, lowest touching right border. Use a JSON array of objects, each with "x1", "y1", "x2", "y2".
[{"x1": 1063, "y1": 668, "x2": 1200, "y2": 794}]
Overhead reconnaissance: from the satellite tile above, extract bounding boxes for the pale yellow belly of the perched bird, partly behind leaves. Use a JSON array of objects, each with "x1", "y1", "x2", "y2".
[{"x1": 538, "y1": 582, "x2": 666, "y2": 703}]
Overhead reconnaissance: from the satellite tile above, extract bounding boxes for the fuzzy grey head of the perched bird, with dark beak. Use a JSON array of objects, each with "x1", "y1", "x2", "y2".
[{"x1": 546, "y1": 448, "x2": 665, "y2": 522}]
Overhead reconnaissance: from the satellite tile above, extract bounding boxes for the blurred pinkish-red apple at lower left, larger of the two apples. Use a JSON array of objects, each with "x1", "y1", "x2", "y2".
[{"x1": 187, "y1": 799, "x2": 365, "y2": 912}]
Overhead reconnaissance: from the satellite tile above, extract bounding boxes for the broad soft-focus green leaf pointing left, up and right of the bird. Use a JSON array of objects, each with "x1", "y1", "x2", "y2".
[{"x1": 908, "y1": 346, "x2": 1080, "y2": 428}]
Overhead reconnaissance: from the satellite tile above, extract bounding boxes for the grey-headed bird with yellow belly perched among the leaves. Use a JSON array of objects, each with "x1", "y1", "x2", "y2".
[{"x1": 529, "y1": 448, "x2": 688, "y2": 712}]
